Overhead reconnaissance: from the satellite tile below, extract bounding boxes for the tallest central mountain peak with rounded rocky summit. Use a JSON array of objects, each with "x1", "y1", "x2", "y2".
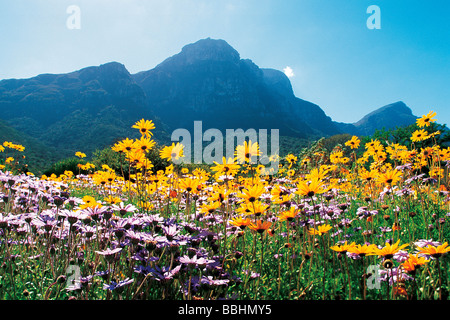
[{"x1": 133, "y1": 38, "x2": 339, "y2": 138}]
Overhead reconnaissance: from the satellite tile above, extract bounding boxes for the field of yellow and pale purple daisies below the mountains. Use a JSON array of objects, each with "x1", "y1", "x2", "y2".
[{"x1": 0, "y1": 112, "x2": 450, "y2": 300}]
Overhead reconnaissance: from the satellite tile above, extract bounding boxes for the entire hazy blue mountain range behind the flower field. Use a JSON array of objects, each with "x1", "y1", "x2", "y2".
[{"x1": 0, "y1": 38, "x2": 416, "y2": 172}]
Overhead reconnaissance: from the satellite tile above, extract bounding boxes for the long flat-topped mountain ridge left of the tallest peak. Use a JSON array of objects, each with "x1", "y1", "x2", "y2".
[{"x1": 0, "y1": 62, "x2": 171, "y2": 162}]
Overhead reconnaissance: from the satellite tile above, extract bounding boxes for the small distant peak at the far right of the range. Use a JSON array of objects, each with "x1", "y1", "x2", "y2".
[{"x1": 335, "y1": 101, "x2": 417, "y2": 136}]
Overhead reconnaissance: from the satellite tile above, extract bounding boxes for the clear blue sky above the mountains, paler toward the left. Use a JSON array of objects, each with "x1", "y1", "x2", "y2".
[{"x1": 0, "y1": 0, "x2": 450, "y2": 125}]
